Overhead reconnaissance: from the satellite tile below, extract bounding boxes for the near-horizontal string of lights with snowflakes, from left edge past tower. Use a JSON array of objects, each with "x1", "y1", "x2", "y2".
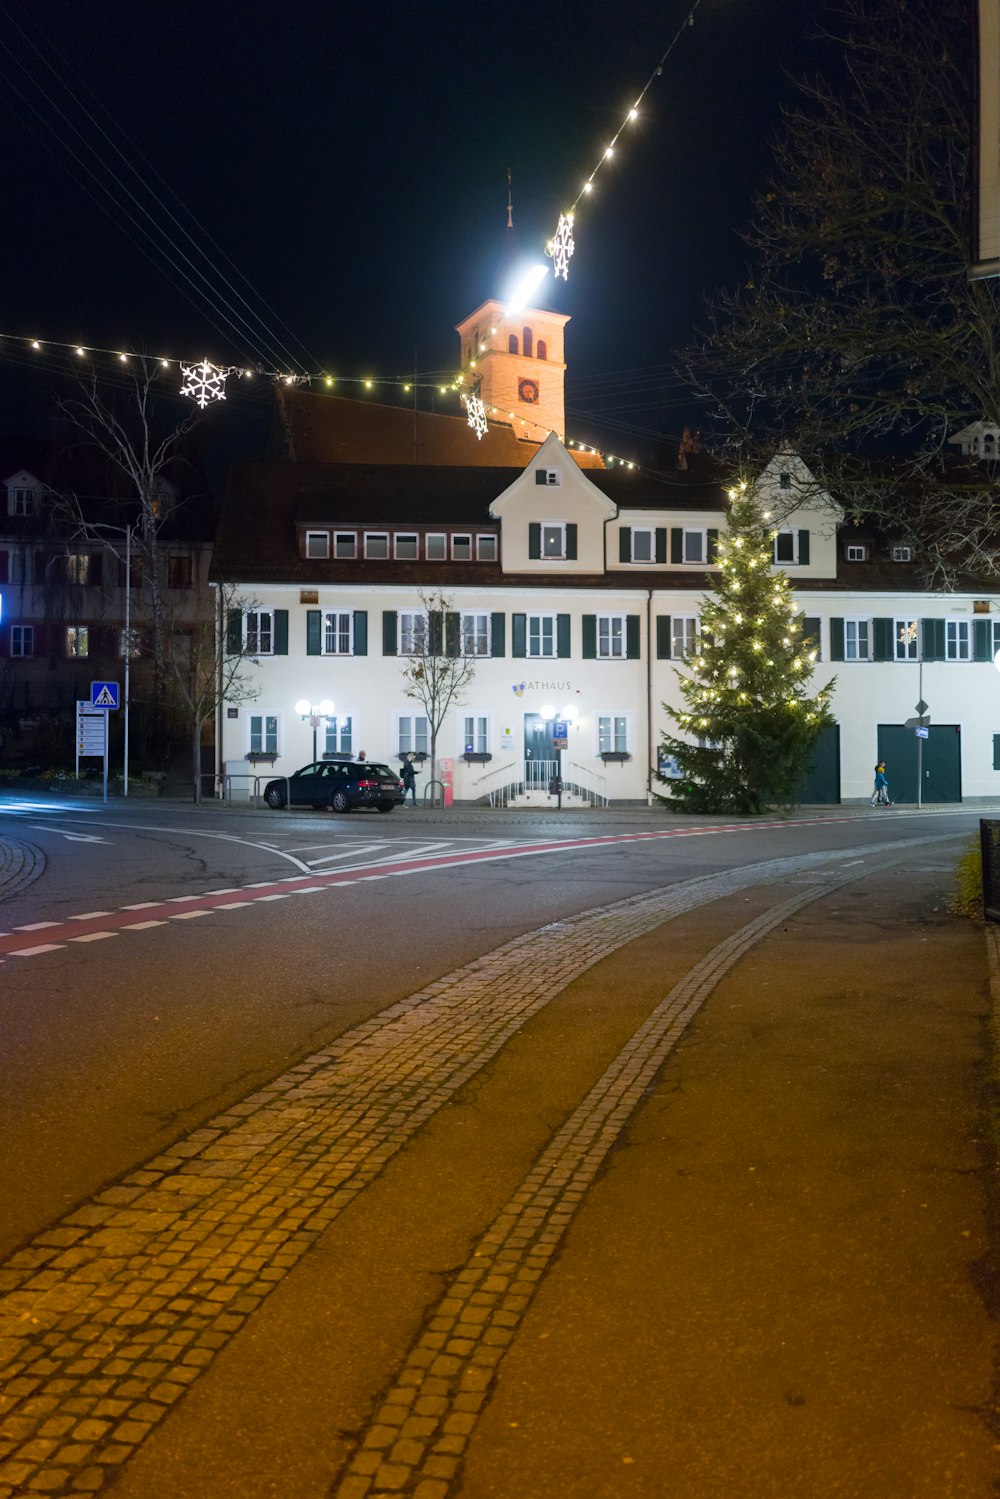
[{"x1": 0, "y1": 333, "x2": 639, "y2": 469}]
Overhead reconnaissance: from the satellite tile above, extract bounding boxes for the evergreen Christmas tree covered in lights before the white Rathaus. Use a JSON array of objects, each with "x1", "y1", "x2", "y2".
[{"x1": 660, "y1": 486, "x2": 834, "y2": 812}]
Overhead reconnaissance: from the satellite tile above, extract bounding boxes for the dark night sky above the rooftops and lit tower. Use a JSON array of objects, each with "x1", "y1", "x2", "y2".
[{"x1": 0, "y1": 0, "x2": 822, "y2": 456}]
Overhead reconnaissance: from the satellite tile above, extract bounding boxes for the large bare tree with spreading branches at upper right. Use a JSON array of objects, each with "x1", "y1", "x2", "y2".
[{"x1": 688, "y1": 0, "x2": 1000, "y2": 586}]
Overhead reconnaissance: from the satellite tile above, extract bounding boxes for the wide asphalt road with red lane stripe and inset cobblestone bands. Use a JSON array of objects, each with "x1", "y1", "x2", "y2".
[{"x1": 0, "y1": 802, "x2": 994, "y2": 1499}]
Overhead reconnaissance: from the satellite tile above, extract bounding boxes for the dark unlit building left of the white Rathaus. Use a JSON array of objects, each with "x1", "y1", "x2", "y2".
[{"x1": 0, "y1": 439, "x2": 216, "y2": 763}]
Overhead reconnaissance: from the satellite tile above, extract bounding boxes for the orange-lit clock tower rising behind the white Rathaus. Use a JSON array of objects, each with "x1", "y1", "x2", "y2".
[{"x1": 457, "y1": 301, "x2": 570, "y2": 442}]
